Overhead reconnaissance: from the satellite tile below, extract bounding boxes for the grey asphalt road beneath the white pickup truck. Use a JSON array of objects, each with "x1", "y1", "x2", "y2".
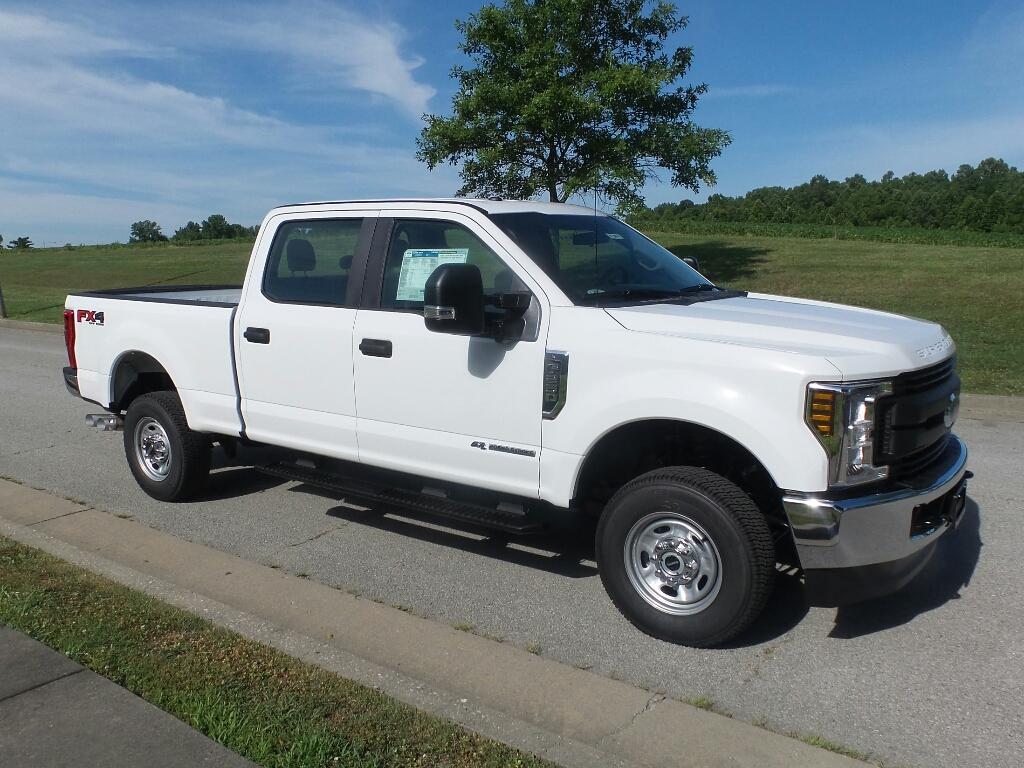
[{"x1": 6, "y1": 329, "x2": 1024, "y2": 768}]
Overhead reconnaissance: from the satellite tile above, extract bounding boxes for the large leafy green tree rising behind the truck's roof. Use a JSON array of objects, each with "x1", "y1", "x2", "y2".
[{"x1": 418, "y1": 0, "x2": 730, "y2": 210}]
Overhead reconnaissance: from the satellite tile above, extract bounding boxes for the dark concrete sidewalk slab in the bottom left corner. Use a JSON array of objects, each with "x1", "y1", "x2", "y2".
[{"x1": 0, "y1": 625, "x2": 253, "y2": 768}]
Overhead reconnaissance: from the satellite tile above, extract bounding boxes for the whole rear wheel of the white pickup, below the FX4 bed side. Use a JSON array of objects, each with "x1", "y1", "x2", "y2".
[{"x1": 124, "y1": 391, "x2": 211, "y2": 502}]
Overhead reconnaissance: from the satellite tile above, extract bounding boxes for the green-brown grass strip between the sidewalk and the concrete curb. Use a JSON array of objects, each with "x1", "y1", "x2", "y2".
[{"x1": 0, "y1": 538, "x2": 550, "y2": 768}]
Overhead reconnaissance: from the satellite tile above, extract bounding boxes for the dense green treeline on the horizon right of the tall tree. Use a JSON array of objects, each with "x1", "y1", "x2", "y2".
[{"x1": 631, "y1": 158, "x2": 1024, "y2": 234}]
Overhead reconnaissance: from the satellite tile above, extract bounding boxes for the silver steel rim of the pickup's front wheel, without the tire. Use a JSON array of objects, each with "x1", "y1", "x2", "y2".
[{"x1": 623, "y1": 512, "x2": 722, "y2": 615}]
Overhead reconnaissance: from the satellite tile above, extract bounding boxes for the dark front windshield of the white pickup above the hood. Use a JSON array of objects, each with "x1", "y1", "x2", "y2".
[{"x1": 490, "y1": 212, "x2": 716, "y2": 304}]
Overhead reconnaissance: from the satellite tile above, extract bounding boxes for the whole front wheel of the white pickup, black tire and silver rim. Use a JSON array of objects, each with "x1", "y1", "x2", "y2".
[{"x1": 596, "y1": 467, "x2": 775, "y2": 647}]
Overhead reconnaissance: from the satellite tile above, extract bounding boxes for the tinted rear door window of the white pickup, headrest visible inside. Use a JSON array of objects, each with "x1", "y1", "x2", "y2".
[{"x1": 263, "y1": 218, "x2": 362, "y2": 306}]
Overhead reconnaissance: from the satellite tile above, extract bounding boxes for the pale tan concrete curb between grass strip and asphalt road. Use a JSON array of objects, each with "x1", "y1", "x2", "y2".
[{"x1": 0, "y1": 481, "x2": 863, "y2": 768}]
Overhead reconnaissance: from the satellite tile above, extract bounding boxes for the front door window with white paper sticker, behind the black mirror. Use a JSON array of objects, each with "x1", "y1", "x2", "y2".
[{"x1": 381, "y1": 219, "x2": 526, "y2": 311}]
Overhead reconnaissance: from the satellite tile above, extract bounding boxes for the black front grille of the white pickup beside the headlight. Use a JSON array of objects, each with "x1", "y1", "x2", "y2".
[{"x1": 874, "y1": 357, "x2": 959, "y2": 479}]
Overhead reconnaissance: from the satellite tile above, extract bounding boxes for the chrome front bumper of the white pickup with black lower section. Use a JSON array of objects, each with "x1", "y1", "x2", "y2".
[{"x1": 782, "y1": 436, "x2": 971, "y2": 605}]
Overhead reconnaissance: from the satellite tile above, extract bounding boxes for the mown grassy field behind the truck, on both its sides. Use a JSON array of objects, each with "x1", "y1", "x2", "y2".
[{"x1": 0, "y1": 231, "x2": 1024, "y2": 394}]
